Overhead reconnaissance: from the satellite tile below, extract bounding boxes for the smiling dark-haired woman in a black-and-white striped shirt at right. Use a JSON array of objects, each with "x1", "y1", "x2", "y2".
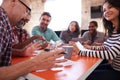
[{"x1": 79, "y1": 0, "x2": 120, "y2": 80}]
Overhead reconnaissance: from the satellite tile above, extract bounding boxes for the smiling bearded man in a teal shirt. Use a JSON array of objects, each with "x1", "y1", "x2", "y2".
[{"x1": 31, "y1": 12, "x2": 61, "y2": 42}]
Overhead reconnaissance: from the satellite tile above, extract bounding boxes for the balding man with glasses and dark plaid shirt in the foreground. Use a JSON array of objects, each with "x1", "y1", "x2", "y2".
[{"x1": 0, "y1": 0, "x2": 65, "y2": 80}]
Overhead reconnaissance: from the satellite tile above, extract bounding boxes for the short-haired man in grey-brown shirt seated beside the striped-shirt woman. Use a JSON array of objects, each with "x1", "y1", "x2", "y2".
[{"x1": 81, "y1": 21, "x2": 105, "y2": 45}]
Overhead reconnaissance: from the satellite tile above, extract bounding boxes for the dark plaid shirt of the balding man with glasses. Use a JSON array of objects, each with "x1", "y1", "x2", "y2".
[{"x1": 0, "y1": 7, "x2": 13, "y2": 66}]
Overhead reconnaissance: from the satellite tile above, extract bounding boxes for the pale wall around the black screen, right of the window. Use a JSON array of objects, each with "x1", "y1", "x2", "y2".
[{"x1": 81, "y1": 0, "x2": 104, "y2": 32}]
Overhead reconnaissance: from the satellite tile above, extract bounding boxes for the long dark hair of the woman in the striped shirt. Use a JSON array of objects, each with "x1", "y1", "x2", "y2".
[{"x1": 103, "y1": 0, "x2": 120, "y2": 36}]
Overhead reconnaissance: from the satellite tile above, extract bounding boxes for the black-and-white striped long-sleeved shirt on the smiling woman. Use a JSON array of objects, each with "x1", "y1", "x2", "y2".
[{"x1": 79, "y1": 32, "x2": 120, "y2": 71}]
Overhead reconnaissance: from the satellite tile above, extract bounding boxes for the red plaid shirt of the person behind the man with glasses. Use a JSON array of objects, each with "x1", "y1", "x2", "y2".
[{"x1": 12, "y1": 27, "x2": 29, "y2": 46}]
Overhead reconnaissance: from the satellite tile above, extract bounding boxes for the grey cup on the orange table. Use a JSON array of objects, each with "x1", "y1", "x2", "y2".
[{"x1": 63, "y1": 46, "x2": 73, "y2": 59}]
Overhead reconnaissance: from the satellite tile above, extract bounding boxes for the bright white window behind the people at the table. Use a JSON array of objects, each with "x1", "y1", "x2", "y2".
[{"x1": 45, "y1": 0, "x2": 81, "y2": 31}]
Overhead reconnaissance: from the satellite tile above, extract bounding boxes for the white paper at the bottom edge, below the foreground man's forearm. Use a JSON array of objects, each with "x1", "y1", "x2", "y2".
[{"x1": 16, "y1": 73, "x2": 45, "y2": 80}]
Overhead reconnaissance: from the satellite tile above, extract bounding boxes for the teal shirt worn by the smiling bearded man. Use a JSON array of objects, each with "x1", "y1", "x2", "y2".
[{"x1": 32, "y1": 26, "x2": 60, "y2": 41}]
